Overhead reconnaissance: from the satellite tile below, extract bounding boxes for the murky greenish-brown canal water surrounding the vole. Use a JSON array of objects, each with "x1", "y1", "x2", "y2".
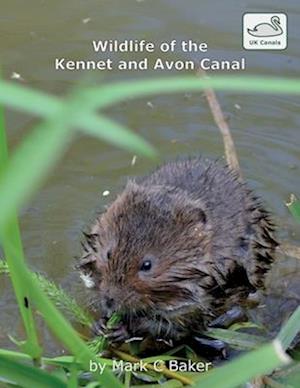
[{"x1": 0, "y1": 0, "x2": 300, "y2": 352}]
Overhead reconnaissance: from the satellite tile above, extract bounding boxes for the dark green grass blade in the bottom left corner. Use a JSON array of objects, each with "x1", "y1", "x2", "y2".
[{"x1": 0, "y1": 355, "x2": 67, "y2": 388}]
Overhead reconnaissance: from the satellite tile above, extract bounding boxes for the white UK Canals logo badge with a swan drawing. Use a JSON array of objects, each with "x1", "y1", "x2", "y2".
[{"x1": 243, "y1": 13, "x2": 287, "y2": 50}]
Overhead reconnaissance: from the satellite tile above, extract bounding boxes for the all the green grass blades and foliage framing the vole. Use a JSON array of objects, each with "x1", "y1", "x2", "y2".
[{"x1": 0, "y1": 77, "x2": 300, "y2": 388}]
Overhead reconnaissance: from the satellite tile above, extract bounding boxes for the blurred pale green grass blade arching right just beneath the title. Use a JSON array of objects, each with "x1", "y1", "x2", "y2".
[{"x1": 81, "y1": 76, "x2": 300, "y2": 109}]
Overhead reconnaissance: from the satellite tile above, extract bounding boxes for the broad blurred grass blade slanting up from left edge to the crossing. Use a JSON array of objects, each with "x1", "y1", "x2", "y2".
[{"x1": 0, "y1": 122, "x2": 70, "y2": 236}]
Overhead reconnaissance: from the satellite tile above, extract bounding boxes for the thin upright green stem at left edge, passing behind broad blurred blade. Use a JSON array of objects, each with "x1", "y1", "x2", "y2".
[{"x1": 0, "y1": 105, "x2": 42, "y2": 362}]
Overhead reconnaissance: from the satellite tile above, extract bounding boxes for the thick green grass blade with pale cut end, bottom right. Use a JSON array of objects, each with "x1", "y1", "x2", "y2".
[{"x1": 194, "y1": 340, "x2": 290, "y2": 388}]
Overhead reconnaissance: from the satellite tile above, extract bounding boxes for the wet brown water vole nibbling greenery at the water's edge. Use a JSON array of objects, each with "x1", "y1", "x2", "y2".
[{"x1": 79, "y1": 158, "x2": 277, "y2": 340}]
